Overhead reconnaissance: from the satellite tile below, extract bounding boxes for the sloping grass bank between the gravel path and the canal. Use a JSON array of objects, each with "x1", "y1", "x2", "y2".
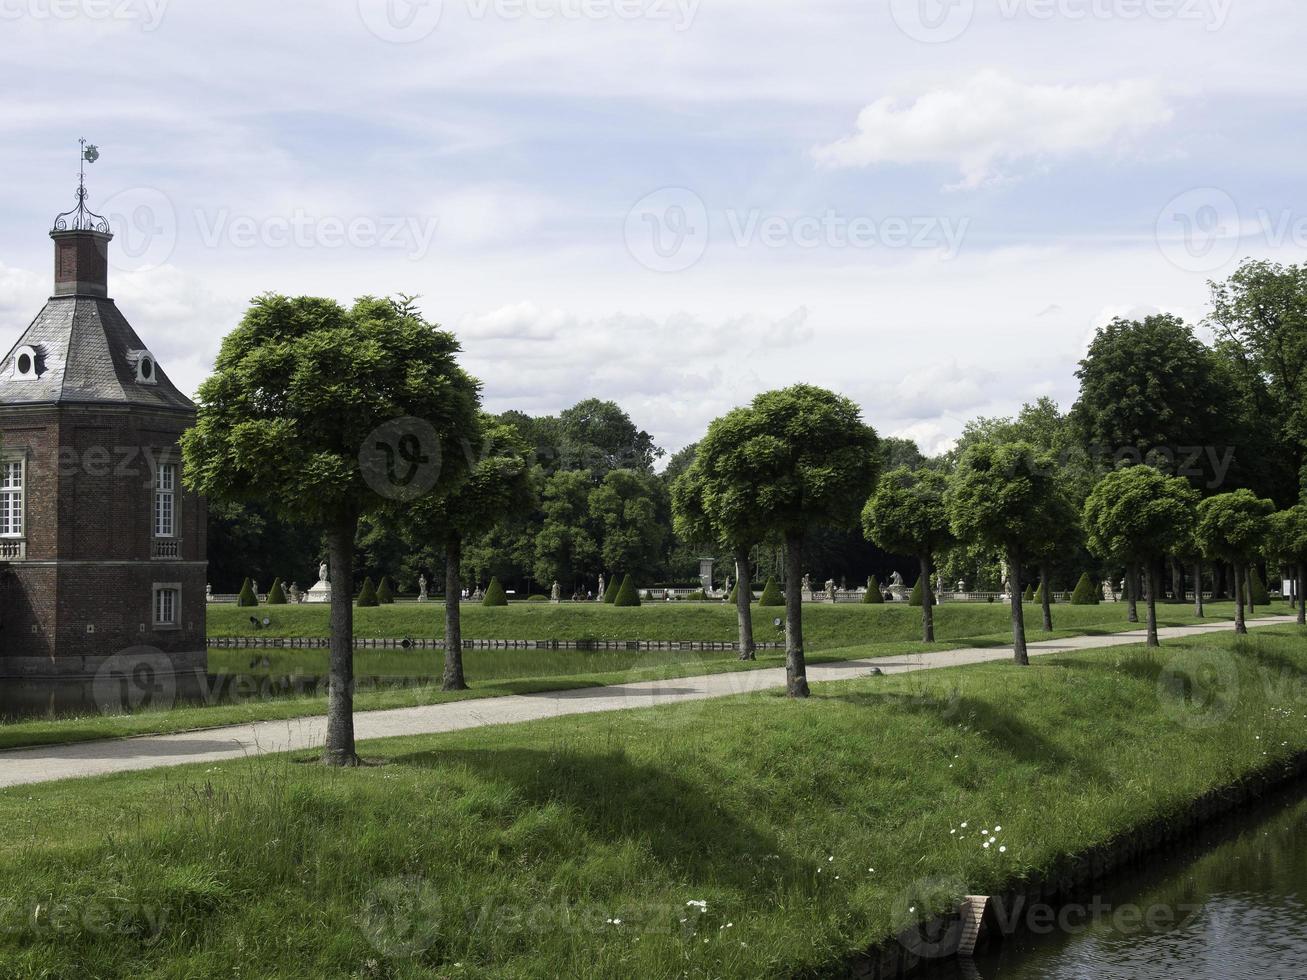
[{"x1": 0, "y1": 627, "x2": 1307, "y2": 977}]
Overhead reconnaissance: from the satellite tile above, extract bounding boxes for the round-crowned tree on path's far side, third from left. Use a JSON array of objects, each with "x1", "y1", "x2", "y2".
[{"x1": 863, "y1": 466, "x2": 953, "y2": 643}]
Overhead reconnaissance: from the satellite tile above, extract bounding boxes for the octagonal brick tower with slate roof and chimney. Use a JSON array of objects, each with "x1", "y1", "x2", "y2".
[{"x1": 0, "y1": 189, "x2": 207, "y2": 710}]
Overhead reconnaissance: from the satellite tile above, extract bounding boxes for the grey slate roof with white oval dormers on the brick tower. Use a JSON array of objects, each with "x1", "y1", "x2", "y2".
[{"x1": 0, "y1": 297, "x2": 195, "y2": 412}]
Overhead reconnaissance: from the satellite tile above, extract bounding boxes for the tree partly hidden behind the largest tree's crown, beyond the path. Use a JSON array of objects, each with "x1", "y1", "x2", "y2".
[{"x1": 401, "y1": 414, "x2": 536, "y2": 691}]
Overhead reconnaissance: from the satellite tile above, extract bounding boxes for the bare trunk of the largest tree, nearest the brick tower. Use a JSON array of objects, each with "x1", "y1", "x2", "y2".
[{"x1": 323, "y1": 515, "x2": 358, "y2": 766}]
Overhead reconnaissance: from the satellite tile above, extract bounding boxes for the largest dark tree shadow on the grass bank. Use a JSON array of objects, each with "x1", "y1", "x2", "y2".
[{"x1": 392, "y1": 749, "x2": 816, "y2": 890}]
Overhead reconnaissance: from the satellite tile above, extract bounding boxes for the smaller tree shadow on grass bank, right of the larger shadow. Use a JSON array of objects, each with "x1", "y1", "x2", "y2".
[{"x1": 831, "y1": 691, "x2": 1102, "y2": 776}]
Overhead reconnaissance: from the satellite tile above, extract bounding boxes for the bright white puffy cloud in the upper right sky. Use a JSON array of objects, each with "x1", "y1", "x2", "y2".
[{"x1": 813, "y1": 71, "x2": 1175, "y2": 188}]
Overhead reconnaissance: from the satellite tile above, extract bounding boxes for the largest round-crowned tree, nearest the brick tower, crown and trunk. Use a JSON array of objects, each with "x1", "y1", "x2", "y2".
[{"x1": 182, "y1": 295, "x2": 477, "y2": 766}]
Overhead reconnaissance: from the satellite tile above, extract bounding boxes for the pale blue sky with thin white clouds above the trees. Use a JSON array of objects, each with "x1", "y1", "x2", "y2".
[{"x1": 0, "y1": 0, "x2": 1307, "y2": 451}]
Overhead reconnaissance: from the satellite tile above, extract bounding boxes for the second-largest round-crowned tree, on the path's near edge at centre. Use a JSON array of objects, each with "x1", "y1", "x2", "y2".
[{"x1": 719, "y1": 384, "x2": 880, "y2": 698}]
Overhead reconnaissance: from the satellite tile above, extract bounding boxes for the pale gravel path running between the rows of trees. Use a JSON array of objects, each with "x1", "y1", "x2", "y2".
[{"x1": 0, "y1": 617, "x2": 1294, "y2": 787}]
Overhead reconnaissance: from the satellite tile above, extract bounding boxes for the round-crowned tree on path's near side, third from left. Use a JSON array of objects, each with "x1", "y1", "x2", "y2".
[{"x1": 945, "y1": 442, "x2": 1060, "y2": 666}]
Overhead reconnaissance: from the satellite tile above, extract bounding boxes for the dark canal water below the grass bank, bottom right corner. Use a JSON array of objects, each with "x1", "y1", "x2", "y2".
[{"x1": 946, "y1": 785, "x2": 1307, "y2": 980}]
